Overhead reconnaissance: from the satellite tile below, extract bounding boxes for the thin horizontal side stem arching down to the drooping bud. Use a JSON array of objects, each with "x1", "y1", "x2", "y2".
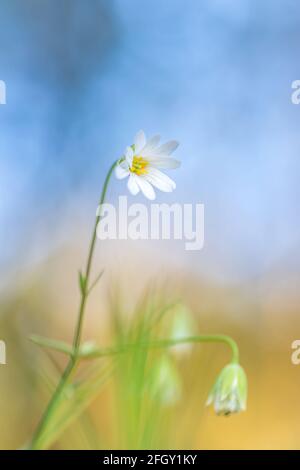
[{"x1": 82, "y1": 335, "x2": 239, "y2": 364}]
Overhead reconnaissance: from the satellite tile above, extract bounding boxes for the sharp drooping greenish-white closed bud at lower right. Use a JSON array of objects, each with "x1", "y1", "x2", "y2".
[{"x1": 206, "y1": 364, "x2": 247, "y2": 416}]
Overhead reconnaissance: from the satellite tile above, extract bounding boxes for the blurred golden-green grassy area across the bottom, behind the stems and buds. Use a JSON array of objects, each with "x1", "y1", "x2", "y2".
[{"x1": 0, "y1": 252, "x2": 300, "y2": 449}]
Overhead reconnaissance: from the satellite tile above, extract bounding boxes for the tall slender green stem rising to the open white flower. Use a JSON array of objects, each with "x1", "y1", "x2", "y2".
[{"x1": 30, "y1": 160, "x2": 119, "y2": 449}]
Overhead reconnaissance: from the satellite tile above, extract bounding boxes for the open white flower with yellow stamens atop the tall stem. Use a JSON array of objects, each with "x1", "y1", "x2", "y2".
[{"x1": 115, "y1": 131, "x2": 180, "y2": 200}]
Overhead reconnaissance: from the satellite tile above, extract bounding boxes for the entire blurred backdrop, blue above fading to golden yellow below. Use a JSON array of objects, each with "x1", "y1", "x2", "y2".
[{"x1": 0, "y1": 0, "x2": 300, "y2": 449}]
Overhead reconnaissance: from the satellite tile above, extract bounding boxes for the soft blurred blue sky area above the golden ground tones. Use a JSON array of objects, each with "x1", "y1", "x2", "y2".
[{"x1": 0, "y1": 0, "x2": 300, "y2": 280}]
